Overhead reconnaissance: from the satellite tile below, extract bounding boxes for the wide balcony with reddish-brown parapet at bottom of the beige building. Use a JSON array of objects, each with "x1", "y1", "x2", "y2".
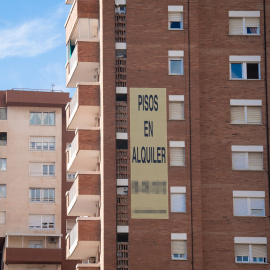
[{"x1": 4, "y1": 234, "x2": 62, "y2": 264}]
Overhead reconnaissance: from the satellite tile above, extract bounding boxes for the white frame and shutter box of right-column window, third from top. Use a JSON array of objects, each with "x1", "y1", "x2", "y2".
[{"x1": 230, "y1": 99, "x2": 262, "y2": 125}]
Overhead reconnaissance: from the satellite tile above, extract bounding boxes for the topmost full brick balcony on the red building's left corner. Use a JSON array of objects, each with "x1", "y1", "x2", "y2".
[{"x1": 65, "y1": 0, "x2": 99, "y2": 44}]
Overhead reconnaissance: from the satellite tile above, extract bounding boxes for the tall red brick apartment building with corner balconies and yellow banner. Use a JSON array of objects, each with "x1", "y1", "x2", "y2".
[{"x1": 65, "y1": 0, "x2": 270, "y2": 270}]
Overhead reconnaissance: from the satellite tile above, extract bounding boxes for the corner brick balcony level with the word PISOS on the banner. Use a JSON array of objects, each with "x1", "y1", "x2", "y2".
[{"x1": 66, "y1": 85, "x2": 100, "y2": 130}]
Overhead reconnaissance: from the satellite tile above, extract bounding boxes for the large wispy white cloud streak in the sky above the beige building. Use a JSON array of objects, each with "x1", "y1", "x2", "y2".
[{"x1": 0, "y1": 7, "x2": 64, "y2": 59}]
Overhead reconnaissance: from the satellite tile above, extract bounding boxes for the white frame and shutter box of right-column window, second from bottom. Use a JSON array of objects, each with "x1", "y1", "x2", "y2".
[{"x1": 233, "y1": 190, "x2": 265, "y2": 217}]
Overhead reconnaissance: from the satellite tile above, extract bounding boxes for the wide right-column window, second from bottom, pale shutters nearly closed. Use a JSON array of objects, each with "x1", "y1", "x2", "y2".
[{"x1": 233, "y1": 191, "x2": 265, "y2": 216}]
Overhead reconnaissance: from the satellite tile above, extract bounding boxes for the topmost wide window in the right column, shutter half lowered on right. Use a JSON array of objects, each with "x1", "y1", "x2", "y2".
[{"x1": 229, "y1": 11, "x2": 260, "y2": 35}]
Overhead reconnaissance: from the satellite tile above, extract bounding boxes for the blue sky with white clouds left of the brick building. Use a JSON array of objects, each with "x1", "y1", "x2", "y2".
[{"x1": 0, "y1": 0, "x2": 73, "y2": 97}]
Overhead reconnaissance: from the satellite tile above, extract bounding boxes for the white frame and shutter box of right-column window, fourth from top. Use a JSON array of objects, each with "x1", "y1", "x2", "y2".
[{"x1": 231, "y1": 145, "x2": 263, "y2": 171}]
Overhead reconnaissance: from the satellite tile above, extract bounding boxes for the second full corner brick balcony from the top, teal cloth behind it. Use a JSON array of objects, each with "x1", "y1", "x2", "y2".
[{"x1": 66, "y1": 41, "x2": 99, "y2": 87}]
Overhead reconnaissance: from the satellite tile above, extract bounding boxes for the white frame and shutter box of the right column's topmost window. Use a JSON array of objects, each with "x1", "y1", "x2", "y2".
[{"x1": 229, "y1": 11, "x2": 260, "y2": 36}]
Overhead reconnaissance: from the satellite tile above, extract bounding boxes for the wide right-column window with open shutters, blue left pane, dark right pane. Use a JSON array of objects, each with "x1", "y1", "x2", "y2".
[{"x1": 230, "y1": 56, "x2": 261, "y2": 80}]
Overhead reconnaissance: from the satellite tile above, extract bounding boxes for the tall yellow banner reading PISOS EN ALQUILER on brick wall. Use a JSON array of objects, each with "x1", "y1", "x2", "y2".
[{"x1": 130, "y1": 88, "x2": 169, "y2": 219}]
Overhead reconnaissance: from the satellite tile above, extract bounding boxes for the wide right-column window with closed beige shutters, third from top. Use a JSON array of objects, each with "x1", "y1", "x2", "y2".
[{"x1": 230, "y1": 99, "x2": 262, "y2": 124}]
